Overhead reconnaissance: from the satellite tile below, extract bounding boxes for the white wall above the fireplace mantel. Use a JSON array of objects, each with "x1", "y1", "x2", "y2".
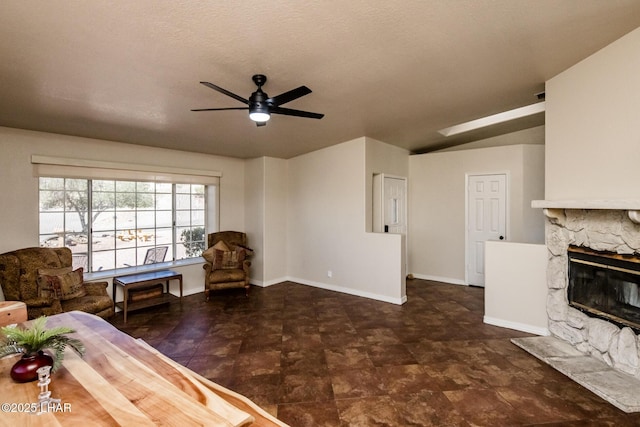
[{"x1": 545, "y1": 28, "x2": 640, "y2": 200}]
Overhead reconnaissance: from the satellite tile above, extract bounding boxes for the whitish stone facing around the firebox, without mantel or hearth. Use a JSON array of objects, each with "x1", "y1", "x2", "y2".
[{"x1": 545, "y1": 208, "x2": 640, "y2": 378}]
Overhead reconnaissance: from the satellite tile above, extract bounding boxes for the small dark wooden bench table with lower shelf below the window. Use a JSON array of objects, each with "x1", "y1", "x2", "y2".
[{"x1": 113, "y1": 270, "x2": 182, "y2": 323}]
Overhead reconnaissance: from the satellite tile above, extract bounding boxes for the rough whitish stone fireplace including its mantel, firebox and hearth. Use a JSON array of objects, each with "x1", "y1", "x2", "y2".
[{"x1": 511, "y1": 206, "x2": 640, "y2": 412}]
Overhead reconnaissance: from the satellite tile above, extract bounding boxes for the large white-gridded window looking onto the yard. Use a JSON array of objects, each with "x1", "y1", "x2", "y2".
[{"x1": 39, "y1": 177, "x2": 208, "y2": 271}]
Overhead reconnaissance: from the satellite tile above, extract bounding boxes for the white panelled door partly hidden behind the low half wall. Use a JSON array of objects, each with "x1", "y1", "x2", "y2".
[{"x1": 467, "y1": 174, "x2": 507, "y2": 286}]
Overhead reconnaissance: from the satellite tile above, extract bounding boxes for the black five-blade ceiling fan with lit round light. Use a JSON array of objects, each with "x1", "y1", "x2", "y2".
[{"x1": 191, "y1": 74, "x2": 324, "y2": 126}]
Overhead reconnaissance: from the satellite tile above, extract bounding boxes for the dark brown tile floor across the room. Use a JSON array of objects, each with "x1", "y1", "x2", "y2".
[{"x1": 107, "y1": 280, "x2": 640, "y2": 427}]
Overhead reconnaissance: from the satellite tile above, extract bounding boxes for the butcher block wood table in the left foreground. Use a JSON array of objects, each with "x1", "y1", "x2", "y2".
[{"x1": 0, "y1": 311, "x2": 286, "y2": 427}]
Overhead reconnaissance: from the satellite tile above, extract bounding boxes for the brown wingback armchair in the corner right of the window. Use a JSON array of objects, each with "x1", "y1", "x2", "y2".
[{"x1": 202, "y1": 231, "x2": 253, "y2": 301}]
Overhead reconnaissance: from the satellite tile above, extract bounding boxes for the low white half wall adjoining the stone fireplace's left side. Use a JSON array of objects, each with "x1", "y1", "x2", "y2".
[{"x1": 484, "y1": 241, "x2": 549, "y2": 335}]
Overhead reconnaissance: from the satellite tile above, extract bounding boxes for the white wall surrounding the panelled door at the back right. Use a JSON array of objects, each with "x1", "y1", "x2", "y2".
[{"x1": 409, "y1": 145, "x2": 544, "y2": 284}]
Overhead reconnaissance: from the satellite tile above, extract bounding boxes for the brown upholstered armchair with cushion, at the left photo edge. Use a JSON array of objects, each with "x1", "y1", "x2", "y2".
[{"x1": 0, "y1": 247, "x2": 115, "y2": 319}]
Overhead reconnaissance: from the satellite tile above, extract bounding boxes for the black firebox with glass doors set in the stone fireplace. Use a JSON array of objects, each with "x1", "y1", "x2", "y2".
[{"x1": 567, "y1": 246, "x2": 640, "y2": 334}]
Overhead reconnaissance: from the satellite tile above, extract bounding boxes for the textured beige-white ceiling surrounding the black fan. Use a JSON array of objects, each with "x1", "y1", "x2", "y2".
[{"x1": 0, "y1": 0, "x2": 640, "y2": 158}]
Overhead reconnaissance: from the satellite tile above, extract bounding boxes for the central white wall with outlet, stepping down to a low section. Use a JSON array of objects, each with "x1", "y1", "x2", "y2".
[{"x1": 287, "y1": 138, "x2": 406, "y2": 304}]
